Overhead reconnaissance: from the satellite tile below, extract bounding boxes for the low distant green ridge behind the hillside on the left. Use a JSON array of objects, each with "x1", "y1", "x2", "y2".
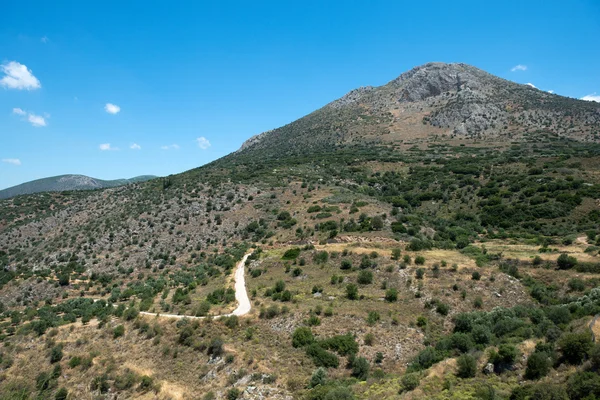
[{"x1": 0, "y1": 175, "x2": 156, "y2": 199}]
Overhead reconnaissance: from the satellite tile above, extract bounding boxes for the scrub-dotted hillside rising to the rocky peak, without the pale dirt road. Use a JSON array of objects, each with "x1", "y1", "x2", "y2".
[{"x1": 0, "y1": 63, "x2": 600, "y2": 400}]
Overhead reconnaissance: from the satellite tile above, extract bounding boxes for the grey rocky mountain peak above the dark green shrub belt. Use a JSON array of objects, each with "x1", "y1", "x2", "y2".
[{"x1": 240, "y1": 62, "x2": 600, "y2": 152}]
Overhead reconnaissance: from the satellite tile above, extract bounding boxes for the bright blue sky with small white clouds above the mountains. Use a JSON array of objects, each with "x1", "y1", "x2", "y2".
[{"x1": 0, "y1": 0, "x2": 600, "y2": 188}]
